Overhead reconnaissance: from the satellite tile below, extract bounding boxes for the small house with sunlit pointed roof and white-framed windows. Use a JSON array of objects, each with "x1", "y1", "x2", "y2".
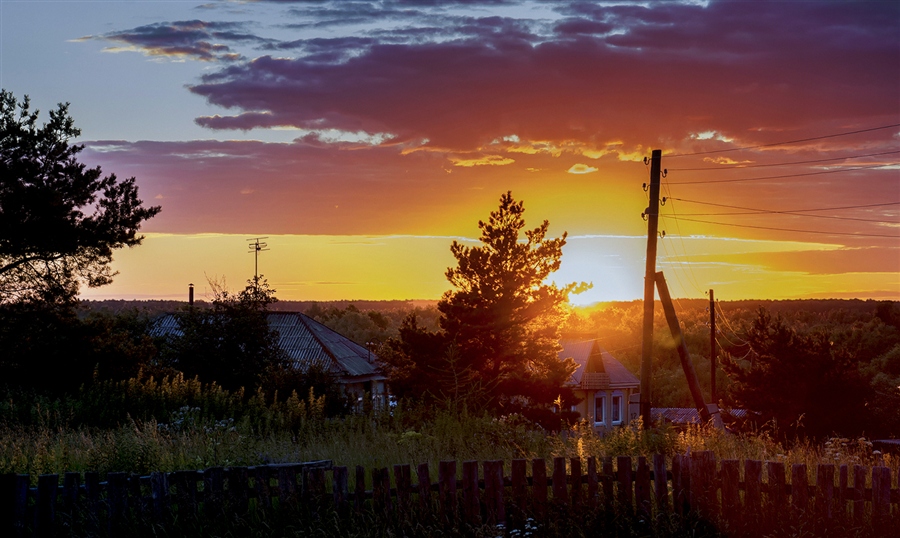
[{"x1": 559, "y1": 339, "x2": 641, "y2": 433}]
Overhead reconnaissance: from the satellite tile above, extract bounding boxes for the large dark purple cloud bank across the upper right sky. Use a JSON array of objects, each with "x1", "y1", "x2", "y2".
[{"x1": 191, "y1": 2, "x2": 900, "y2": 150}]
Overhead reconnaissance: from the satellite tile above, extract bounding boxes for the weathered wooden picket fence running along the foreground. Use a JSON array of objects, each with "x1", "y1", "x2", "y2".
[{"x1": 0, "y1": 452, "x2": 900, "y2": 537}]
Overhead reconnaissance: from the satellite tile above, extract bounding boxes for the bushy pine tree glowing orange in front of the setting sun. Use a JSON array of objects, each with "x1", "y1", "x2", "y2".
[{"x1": 385, "y1": 192, "x2": 585, "y2": 412}]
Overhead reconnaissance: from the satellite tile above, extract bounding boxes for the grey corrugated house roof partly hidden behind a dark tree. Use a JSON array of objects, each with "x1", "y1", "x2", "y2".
[{"x1": 151, "y1": 312, "x2": 384, "y2": 383}]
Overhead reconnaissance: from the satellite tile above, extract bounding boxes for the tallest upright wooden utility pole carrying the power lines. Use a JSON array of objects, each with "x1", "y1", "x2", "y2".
[{"x1": 640, "y1": 149, "x2": 662, "y2": 428}]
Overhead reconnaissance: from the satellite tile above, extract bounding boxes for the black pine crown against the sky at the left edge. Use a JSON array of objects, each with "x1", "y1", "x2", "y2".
[{"x1": 0, "y1": 90, "x2": 160, "y2": 303}]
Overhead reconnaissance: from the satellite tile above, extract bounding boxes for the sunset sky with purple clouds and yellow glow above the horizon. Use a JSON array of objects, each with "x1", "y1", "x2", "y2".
[{"x1": 0, "y1": 0, "x2": 900, "y2": 304}]
